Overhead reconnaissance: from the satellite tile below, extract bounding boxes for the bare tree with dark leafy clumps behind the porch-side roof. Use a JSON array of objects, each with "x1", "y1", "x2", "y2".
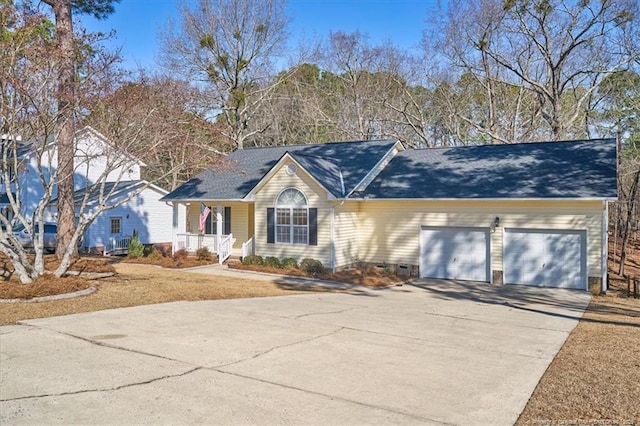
[{"x1": 161, "y1": 0, "x2": 288, "y2": 149}]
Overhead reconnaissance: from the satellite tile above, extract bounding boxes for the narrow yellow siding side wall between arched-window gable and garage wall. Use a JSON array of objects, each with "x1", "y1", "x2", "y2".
[{"x1": 335, "y1": 202, "x2": 359, "y2": 266}]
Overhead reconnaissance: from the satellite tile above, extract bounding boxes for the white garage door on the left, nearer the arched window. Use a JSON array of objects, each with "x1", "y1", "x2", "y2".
[{"x1": 420, "y1": 227, "x2": 489, "y2": 281}]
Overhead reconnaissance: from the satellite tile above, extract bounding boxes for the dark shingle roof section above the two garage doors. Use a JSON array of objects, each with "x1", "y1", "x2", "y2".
[{"x1": 357, "y1": 139, "x2": 617, "y2": 199}]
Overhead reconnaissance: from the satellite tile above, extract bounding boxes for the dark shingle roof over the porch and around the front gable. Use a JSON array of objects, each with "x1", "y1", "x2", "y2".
[{"x1": 163, "y1": 140, "x2": 396, "y2": 201}]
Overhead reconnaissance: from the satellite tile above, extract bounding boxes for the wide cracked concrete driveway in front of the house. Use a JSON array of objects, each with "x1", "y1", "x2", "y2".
[{"x1": 0, "y1": 281, "x2": 589, "y2": 425}]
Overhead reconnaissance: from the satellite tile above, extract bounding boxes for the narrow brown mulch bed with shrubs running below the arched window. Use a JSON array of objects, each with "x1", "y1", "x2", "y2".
[{"x1": 229, "y1": 262, "x2": 404, "y2": 287}]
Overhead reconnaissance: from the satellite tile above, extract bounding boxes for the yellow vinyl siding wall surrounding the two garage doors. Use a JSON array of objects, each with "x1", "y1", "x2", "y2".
[{"x1": 358, "y1": 200, "x2": 602, "y2": 276}]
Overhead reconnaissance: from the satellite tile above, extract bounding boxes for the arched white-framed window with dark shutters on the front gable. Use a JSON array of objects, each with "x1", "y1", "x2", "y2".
[{"x1": 267, "y1": 188, "x2": 318, "y2": 245}]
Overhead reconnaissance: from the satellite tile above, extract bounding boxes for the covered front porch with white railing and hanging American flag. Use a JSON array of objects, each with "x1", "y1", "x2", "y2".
[{"x1": 173, "y1": 201, "x2": 255, "y2": 263}]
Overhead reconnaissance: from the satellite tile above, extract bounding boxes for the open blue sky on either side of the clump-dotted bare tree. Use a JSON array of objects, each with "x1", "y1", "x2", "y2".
[{"x1": 82, "y1": 0, "x2": 438, "y2": 68}]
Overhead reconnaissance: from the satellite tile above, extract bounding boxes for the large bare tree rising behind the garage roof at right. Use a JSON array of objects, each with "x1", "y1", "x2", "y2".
[{"x1": 434, "y1": 0, "x2": 638, "y2": 141}]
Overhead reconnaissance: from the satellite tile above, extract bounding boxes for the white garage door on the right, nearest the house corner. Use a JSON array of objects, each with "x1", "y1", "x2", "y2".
[{"x1": 504, "y1": 229, "x2": 587, "y2": 289}]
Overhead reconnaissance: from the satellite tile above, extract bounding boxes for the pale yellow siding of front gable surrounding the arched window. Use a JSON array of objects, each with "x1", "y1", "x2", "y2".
[{"x1": 254, "y1": 161, "x2": 331, "y2": 267}]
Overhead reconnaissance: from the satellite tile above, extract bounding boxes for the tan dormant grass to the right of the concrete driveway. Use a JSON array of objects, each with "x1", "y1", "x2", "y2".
[{"x1": 516, "y1": 296, "x2": 640, "y2": 425}]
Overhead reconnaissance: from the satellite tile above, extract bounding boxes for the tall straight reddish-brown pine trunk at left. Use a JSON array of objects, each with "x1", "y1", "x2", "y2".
[{"x1": 51, "y1": 0, "x2": 77, "y2": 259}]
